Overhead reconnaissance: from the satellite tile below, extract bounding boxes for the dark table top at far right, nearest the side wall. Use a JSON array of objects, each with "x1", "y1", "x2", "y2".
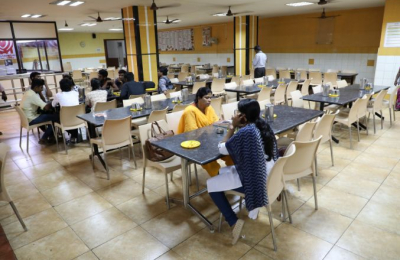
[{"x1": 303, "y1": 84, "x2": 390, "y2": 105}]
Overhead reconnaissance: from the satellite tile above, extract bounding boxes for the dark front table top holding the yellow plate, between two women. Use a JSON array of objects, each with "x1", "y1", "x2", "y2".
[{"x1": 153, "y1": 106, "x2": 323, "y2": 165}]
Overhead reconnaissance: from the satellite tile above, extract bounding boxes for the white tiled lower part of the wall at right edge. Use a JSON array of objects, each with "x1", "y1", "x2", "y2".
[{"x1": 375, "y1": 56, "x2": 400, "y2": 86}]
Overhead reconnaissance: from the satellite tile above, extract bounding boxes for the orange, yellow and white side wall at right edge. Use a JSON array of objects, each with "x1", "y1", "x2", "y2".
[{"x1": 375, "y1": 0, "x2": 400, "y2": 86}]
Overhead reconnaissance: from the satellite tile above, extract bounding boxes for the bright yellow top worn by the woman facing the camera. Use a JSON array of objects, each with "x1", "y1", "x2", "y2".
[{"x1": 178, "y1": 104, "x2": 218, "y2": 134}]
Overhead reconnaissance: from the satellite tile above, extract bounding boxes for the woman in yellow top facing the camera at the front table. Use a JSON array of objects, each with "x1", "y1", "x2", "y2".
[{"x1": 178, "y1": 87, "x2": 233, "y2": 177}]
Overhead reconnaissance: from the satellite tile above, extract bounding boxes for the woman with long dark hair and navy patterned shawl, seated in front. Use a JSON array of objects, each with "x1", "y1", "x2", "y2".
[{"x1": 207, "y1": 99, "x2": 278, "y2": 244}]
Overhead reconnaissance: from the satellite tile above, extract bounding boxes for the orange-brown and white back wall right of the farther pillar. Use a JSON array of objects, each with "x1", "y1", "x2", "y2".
[{"x1": 259, "y1": 7, "x2": 384, "y2": 82}]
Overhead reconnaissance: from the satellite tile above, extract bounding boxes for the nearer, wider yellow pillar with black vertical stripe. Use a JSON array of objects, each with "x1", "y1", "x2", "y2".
[{"x1": 122, "y1": 6, "x2": 159, "y2": 82}]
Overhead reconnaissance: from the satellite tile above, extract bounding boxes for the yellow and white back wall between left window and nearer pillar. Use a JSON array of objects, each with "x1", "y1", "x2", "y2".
[{"x1": 58, "y1": 32, "x2": 124, "y2": 69}]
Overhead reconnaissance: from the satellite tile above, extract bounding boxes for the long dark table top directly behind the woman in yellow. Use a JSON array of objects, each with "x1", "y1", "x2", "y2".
[{"x1": 77, "y1": 95, "x2": 196, "y2": 126}]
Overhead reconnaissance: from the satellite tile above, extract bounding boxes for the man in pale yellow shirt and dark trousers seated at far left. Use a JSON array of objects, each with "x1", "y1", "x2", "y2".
[{"x1": 21, "y1": 79, "x2": 59, "y2": 144}]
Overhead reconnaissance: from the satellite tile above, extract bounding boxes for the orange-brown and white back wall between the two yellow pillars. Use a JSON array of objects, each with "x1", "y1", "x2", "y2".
[{"x1": 159, "y1": 22, "x2": 233, "y2": 65}]
